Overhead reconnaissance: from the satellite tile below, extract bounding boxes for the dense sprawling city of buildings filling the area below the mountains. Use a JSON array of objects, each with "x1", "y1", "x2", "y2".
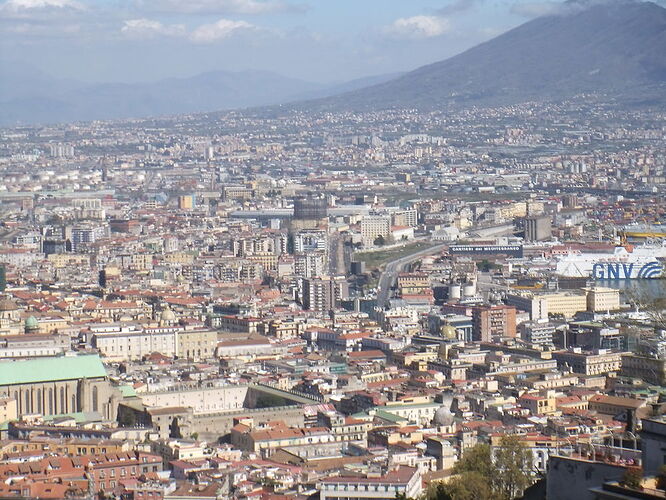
[{"x1": 0, "y1": 96, "x2": 666, "y2": 500}]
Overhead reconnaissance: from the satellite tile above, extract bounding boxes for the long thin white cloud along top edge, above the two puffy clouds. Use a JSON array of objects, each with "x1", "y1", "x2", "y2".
[{"x1": 144, "y1": 0, "x2": 304, "y2": 15}]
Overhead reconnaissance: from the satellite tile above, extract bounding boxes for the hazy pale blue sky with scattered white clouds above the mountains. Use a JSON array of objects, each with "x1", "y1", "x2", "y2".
[{"x1": 0, "y1": 0, "x2": 584, "y2": 82}]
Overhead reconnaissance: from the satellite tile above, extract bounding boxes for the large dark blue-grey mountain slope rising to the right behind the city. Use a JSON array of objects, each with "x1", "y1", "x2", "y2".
[{"x1": 299, "y1": 0, "x2": 666, "y2": 109}]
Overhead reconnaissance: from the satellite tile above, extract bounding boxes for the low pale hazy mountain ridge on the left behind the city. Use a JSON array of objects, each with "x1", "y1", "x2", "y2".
[{"x1": 0, "y1": 69, "x2": 330, "y2": 125}]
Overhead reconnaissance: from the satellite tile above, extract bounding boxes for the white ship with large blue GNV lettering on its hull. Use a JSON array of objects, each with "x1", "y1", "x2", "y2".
[{"x1": 556, "y1": 245, "x2": 666, "y2": 280}]
